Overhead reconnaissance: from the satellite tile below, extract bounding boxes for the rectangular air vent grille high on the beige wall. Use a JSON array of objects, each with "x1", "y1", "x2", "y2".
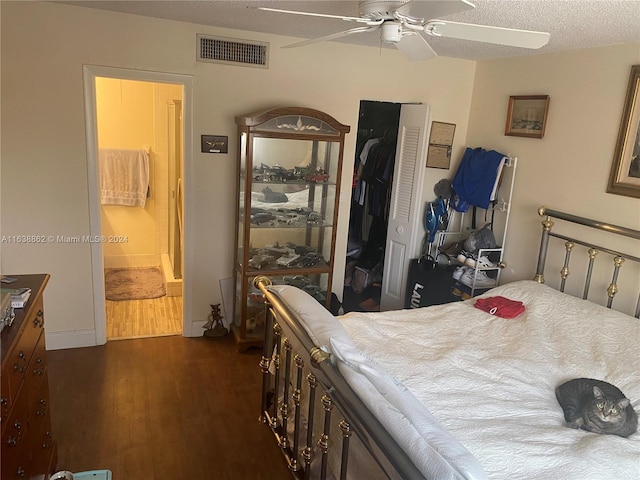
[{"x1": 197, "y1": 34, "x2": 269, "y2": 68}]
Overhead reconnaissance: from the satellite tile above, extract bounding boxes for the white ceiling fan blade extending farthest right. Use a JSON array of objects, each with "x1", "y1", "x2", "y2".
[{"x1": 425, "y1": 20, "x2": 551, "y2": 49}]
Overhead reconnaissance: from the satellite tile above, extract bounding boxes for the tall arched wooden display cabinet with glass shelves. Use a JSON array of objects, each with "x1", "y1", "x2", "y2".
[{"x1": 231, "y1": 107, "x2": 350, "y2": 350}]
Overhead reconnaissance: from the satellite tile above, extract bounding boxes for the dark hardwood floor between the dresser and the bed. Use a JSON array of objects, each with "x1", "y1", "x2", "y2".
[{"x1": 47, "y1": 335, "x2": 292, "y2": 480}]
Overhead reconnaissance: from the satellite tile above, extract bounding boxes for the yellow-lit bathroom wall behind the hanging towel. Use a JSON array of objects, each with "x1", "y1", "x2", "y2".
[{"x1": 96, "y1": 78, "x2": 181, "y2": 268}]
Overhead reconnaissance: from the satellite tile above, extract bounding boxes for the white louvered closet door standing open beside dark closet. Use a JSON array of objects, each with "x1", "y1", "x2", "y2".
[{"x1": 380, "y1": 105, "x2": 431, "y2": 310}]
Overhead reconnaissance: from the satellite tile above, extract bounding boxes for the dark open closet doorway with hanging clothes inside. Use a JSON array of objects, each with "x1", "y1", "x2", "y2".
[{"x1": 343, "y1": 100, "x2": 402, "y2": 312}]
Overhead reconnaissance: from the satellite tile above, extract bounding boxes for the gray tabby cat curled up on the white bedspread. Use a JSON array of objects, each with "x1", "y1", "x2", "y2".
[{"x1": 556, "y1": 378, "x2": 638, "y2": 437}]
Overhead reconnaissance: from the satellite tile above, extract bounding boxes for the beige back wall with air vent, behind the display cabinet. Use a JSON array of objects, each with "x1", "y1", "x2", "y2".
[{"x1": 0, "y1": 1, "x2": 476, "y2": 348}]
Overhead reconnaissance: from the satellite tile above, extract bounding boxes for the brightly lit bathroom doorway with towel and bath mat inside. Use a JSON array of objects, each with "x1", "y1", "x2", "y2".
[{"x1": 85, "y1": 67, "x2": 190, "y2": 344}]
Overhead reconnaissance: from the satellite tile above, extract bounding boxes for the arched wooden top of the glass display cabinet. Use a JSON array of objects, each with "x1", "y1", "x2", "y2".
[{"x1": 236, "y1": 107, "x2": 351, "y2": 136}]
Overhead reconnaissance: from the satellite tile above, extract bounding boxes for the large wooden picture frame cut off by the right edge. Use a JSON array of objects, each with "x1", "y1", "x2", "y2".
[{"x1": 607, "y1": 65, "x2": 640, "y2": 198}]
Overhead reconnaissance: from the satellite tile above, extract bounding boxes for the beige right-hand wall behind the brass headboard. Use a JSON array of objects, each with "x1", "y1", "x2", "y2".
[{"x1": 467, "y1": 43, "x2": 640, "y2": 312}]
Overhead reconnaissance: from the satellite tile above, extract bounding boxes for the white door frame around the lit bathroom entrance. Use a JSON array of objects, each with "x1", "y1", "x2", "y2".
[{"x1": 82, "y1": 65, "x2": 195, "y2": 345}]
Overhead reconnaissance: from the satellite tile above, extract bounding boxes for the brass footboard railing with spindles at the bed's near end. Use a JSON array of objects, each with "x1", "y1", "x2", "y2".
[{"x1": 254, "y1": 276, "x2": 425, "y2": 480}]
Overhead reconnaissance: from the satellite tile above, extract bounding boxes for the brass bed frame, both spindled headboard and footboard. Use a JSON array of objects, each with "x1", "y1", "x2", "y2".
[{"x1": 254, "y1": 207, "x2": 640, "y2": 480}]
